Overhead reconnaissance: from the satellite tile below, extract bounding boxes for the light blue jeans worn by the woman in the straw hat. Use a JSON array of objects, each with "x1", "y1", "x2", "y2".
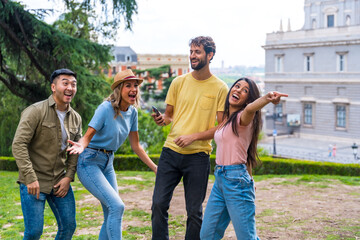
[{"x1": 77, "y1": 148, "x2": 125, "y2": 240}]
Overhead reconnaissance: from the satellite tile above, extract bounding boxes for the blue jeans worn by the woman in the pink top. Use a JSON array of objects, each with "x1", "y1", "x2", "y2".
[{"x1": 200, "y1": 164, "x2": 259, "y2": 240}]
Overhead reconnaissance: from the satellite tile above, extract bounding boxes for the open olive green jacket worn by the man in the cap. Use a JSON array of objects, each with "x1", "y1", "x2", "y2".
[{"x1": 12, "y1": 95, "x2": 82, "y2": 193}]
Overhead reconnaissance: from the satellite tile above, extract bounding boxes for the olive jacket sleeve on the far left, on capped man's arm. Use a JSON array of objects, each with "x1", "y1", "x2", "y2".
[{"x1": 12, "y1": 106, "x2": 41, "y2": 185}]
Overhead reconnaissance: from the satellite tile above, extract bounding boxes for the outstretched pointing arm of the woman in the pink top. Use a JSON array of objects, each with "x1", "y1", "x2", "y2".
[{"x1": 240, "y1": 92, "x2": 288, "y2": 126}]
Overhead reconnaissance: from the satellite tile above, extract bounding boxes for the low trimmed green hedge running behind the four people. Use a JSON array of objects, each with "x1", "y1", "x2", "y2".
[{"x1": 0, "y1": 154, "x2": 360, "y2": 176}]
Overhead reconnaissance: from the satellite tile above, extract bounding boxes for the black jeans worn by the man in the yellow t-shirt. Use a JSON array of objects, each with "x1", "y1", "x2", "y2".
[{"x1": 151, "y1": 147, "x2": 210, "y2": 240}]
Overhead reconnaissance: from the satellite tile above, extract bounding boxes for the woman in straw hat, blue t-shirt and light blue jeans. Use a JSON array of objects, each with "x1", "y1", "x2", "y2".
[{"x1": 68, "y1": 69, "x2": 157, "y2": 240}]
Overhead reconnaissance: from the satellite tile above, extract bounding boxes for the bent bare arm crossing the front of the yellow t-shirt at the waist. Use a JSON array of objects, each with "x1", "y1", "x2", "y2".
[{"x1": 174, "y1": 112, "x2": 224, "y2": 148}]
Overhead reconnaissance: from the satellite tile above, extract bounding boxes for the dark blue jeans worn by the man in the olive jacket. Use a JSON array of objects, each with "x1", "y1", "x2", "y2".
[{"x1": 20, "y1": 183, "x2": 76, "y2": 240}]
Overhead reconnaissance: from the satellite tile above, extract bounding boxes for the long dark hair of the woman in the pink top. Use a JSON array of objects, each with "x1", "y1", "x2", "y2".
[{"x1": 221, "y1": 78, "x2": 262, "y2": 169}]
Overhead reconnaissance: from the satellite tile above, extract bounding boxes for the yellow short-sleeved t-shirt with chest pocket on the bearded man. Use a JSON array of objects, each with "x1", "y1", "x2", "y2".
[{"x1": 164, "y1": 73, "x2": 228, "y2": 154}]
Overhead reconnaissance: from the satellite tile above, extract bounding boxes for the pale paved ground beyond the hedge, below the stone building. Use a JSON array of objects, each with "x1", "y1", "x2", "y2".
[{"x1": 259, "y1": 136, "x2": 360, "y2": 164}]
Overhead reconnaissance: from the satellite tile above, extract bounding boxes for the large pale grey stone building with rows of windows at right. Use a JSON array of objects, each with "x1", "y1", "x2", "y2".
[{"x1": 263, "y1": 0, "x2": 360, "y2": 142}]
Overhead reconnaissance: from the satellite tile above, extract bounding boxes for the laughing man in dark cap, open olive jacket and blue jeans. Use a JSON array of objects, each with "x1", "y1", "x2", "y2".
[{"x1": 12, "y1": 69, "x2": 82, "y2": 239}]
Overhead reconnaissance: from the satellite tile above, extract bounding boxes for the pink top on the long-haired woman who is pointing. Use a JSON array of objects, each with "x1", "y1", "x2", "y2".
[{"x1": 214, "y1": 111, "x2": 252, "y2": 165}]
